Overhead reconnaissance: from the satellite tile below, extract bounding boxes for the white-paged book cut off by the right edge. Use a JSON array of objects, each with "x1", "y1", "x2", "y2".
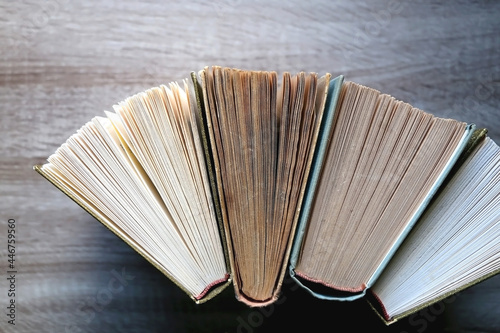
[{"x1": 371, "y1": 134, "x2": 500, "y2": 323}]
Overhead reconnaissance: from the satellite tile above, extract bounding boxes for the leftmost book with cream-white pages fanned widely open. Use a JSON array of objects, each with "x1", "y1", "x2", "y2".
[{"x1": 37, "y1": 81, "x2": 229, "y2": 302}]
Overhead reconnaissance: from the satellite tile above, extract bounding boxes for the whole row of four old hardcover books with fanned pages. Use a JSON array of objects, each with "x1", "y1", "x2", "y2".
[{"x1": 34, "y1": 66, "x2": 500, "y2": 324}]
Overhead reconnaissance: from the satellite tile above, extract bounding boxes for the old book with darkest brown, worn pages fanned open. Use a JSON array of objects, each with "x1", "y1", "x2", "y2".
[{"x1": 201, "y1": 66, "x2": 330, "y2": 306}]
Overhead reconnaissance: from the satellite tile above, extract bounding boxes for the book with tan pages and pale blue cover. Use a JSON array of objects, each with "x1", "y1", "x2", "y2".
[{"x1": 294, "y1": 82, "x2": 473, "y2": 300}]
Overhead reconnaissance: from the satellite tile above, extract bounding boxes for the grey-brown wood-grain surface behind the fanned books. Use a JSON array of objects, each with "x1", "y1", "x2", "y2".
[{"x1": 0, "y1": 0, "x2": 500, "y2": 332}]
